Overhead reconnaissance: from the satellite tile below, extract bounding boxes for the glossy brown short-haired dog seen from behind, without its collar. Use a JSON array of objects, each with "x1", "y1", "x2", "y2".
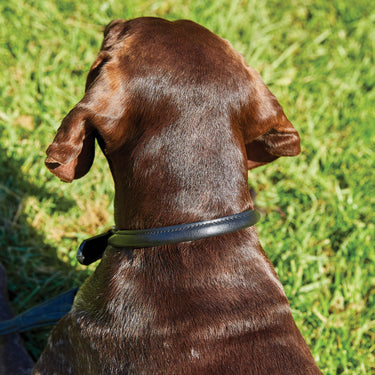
[{"x1": 34, "y1": 18, "x2": 321, "y2": 375}]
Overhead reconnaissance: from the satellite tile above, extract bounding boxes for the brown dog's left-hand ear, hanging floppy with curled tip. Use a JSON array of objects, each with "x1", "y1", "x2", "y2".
[{"x1": 45, "y1": 104, "x2": 95, "y2": 182}]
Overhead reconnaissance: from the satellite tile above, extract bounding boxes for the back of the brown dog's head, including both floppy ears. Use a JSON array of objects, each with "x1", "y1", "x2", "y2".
[{"x1": 46, "y1": 18, "x2": 300, "y2": 182}]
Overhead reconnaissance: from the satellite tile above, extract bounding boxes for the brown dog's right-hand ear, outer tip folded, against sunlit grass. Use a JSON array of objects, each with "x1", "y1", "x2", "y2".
[{"x1": 242, "y1": 67, "x2": 301, "y2": 169}]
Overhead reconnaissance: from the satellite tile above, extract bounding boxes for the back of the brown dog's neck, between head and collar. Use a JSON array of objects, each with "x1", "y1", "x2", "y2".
[{"x1": 108, "y1": 119, "x2": 253, "y2": 229}]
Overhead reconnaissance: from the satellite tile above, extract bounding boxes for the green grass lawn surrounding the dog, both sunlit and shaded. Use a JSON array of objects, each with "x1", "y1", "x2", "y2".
[{"x1": 0, "y1": 0, "x2": 375, "y2": 375}]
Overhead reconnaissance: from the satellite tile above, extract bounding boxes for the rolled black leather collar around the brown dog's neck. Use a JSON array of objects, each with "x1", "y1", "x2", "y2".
[{"x1": 77, "y1": 210, "x2": 260, "y2": 265}]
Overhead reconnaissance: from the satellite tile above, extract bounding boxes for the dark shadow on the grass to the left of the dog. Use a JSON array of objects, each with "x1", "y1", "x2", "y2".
[{"x1": 0, "y1": 142, "x2": 88, "y2": 360}]
